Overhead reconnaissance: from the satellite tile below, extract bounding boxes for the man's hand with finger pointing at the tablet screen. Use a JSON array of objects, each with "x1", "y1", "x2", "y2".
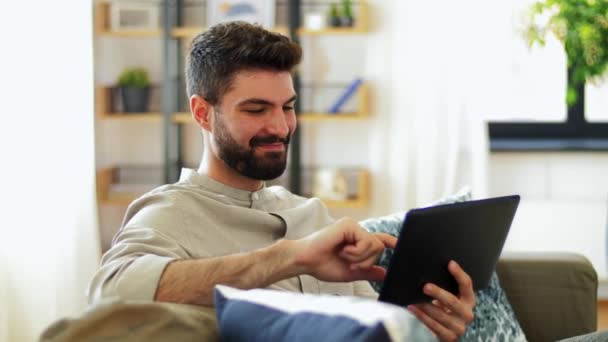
[{"x1": 294, "y1": 218, "x2": 397, "y2": 282}]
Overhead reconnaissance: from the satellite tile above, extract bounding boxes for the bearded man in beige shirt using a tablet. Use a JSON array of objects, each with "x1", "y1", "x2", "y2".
[{"x1": 89, "y1": 22, "x2": 475, "y2": 340}]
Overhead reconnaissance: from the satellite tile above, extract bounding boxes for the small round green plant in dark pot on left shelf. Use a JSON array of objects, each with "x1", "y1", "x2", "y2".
[{"x1": 118, "y1": 68, "x2": 150, "y2": 113}]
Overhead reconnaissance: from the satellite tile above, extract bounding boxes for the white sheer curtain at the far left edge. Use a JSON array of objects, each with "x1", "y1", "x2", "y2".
[{"x1": 0, "y1": 0, "x2": 99, "y2": 341}]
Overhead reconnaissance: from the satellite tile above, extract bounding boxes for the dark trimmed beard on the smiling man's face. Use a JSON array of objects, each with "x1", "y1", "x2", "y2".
[{"x1": 213, "y1": 111, "x2": 291, "y2": 180}]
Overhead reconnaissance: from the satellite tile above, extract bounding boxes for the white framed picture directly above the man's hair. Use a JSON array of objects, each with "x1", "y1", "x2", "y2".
[{"x1": 207, "y1": 0, "x2": 275, "y2": 29}]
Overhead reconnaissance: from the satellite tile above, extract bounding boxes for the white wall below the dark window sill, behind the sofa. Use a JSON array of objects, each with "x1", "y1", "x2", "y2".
[{"x1": 490, "y1": 153, "x2": 608, "y2": 278}]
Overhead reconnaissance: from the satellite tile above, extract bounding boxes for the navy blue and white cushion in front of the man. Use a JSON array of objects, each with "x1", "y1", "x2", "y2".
[{"x1": 215, "y1": 285, "x2": 436, "y2": 342}]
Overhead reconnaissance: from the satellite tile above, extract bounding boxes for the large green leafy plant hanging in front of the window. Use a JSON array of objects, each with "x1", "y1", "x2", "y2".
[{"x1": 525, "y1": 0, "x2": 608, "y2": 106}]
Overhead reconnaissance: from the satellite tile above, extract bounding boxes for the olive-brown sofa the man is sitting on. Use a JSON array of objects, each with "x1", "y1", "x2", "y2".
[{"x1": 40, "y1": 253, "x2": 598, "y2": 342}]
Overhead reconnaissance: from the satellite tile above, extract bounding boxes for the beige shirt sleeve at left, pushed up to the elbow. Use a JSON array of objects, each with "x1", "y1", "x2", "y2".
[{"x1": 87, "y1": 193, "x2": 188, "y2": 303}]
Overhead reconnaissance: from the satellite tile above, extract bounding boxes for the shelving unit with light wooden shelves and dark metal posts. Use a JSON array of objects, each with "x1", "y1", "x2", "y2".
[{"x1": 95, "y1": 0, "x2": 370, "y2": 208}]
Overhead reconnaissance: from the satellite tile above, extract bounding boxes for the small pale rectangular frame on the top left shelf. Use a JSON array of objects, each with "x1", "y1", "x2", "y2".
[{"x1": 110, "y1": 2, "x2": 160, "y2": 31}]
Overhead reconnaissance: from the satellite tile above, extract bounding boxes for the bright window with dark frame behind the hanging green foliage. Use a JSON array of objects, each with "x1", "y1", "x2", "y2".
[{"x1": 489, "y1": 0, "x2": 608, "y2": 151}]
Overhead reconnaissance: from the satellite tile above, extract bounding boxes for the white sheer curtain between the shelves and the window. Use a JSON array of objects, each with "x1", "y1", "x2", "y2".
[{"x1": 376, "y1": 0, "x2": 511, "y2": 211}]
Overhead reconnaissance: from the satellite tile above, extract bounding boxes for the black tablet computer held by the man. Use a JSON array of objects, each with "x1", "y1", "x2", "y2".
[{"x1": 378, "y1": 195, "x2": 519, "y2": 306}]
